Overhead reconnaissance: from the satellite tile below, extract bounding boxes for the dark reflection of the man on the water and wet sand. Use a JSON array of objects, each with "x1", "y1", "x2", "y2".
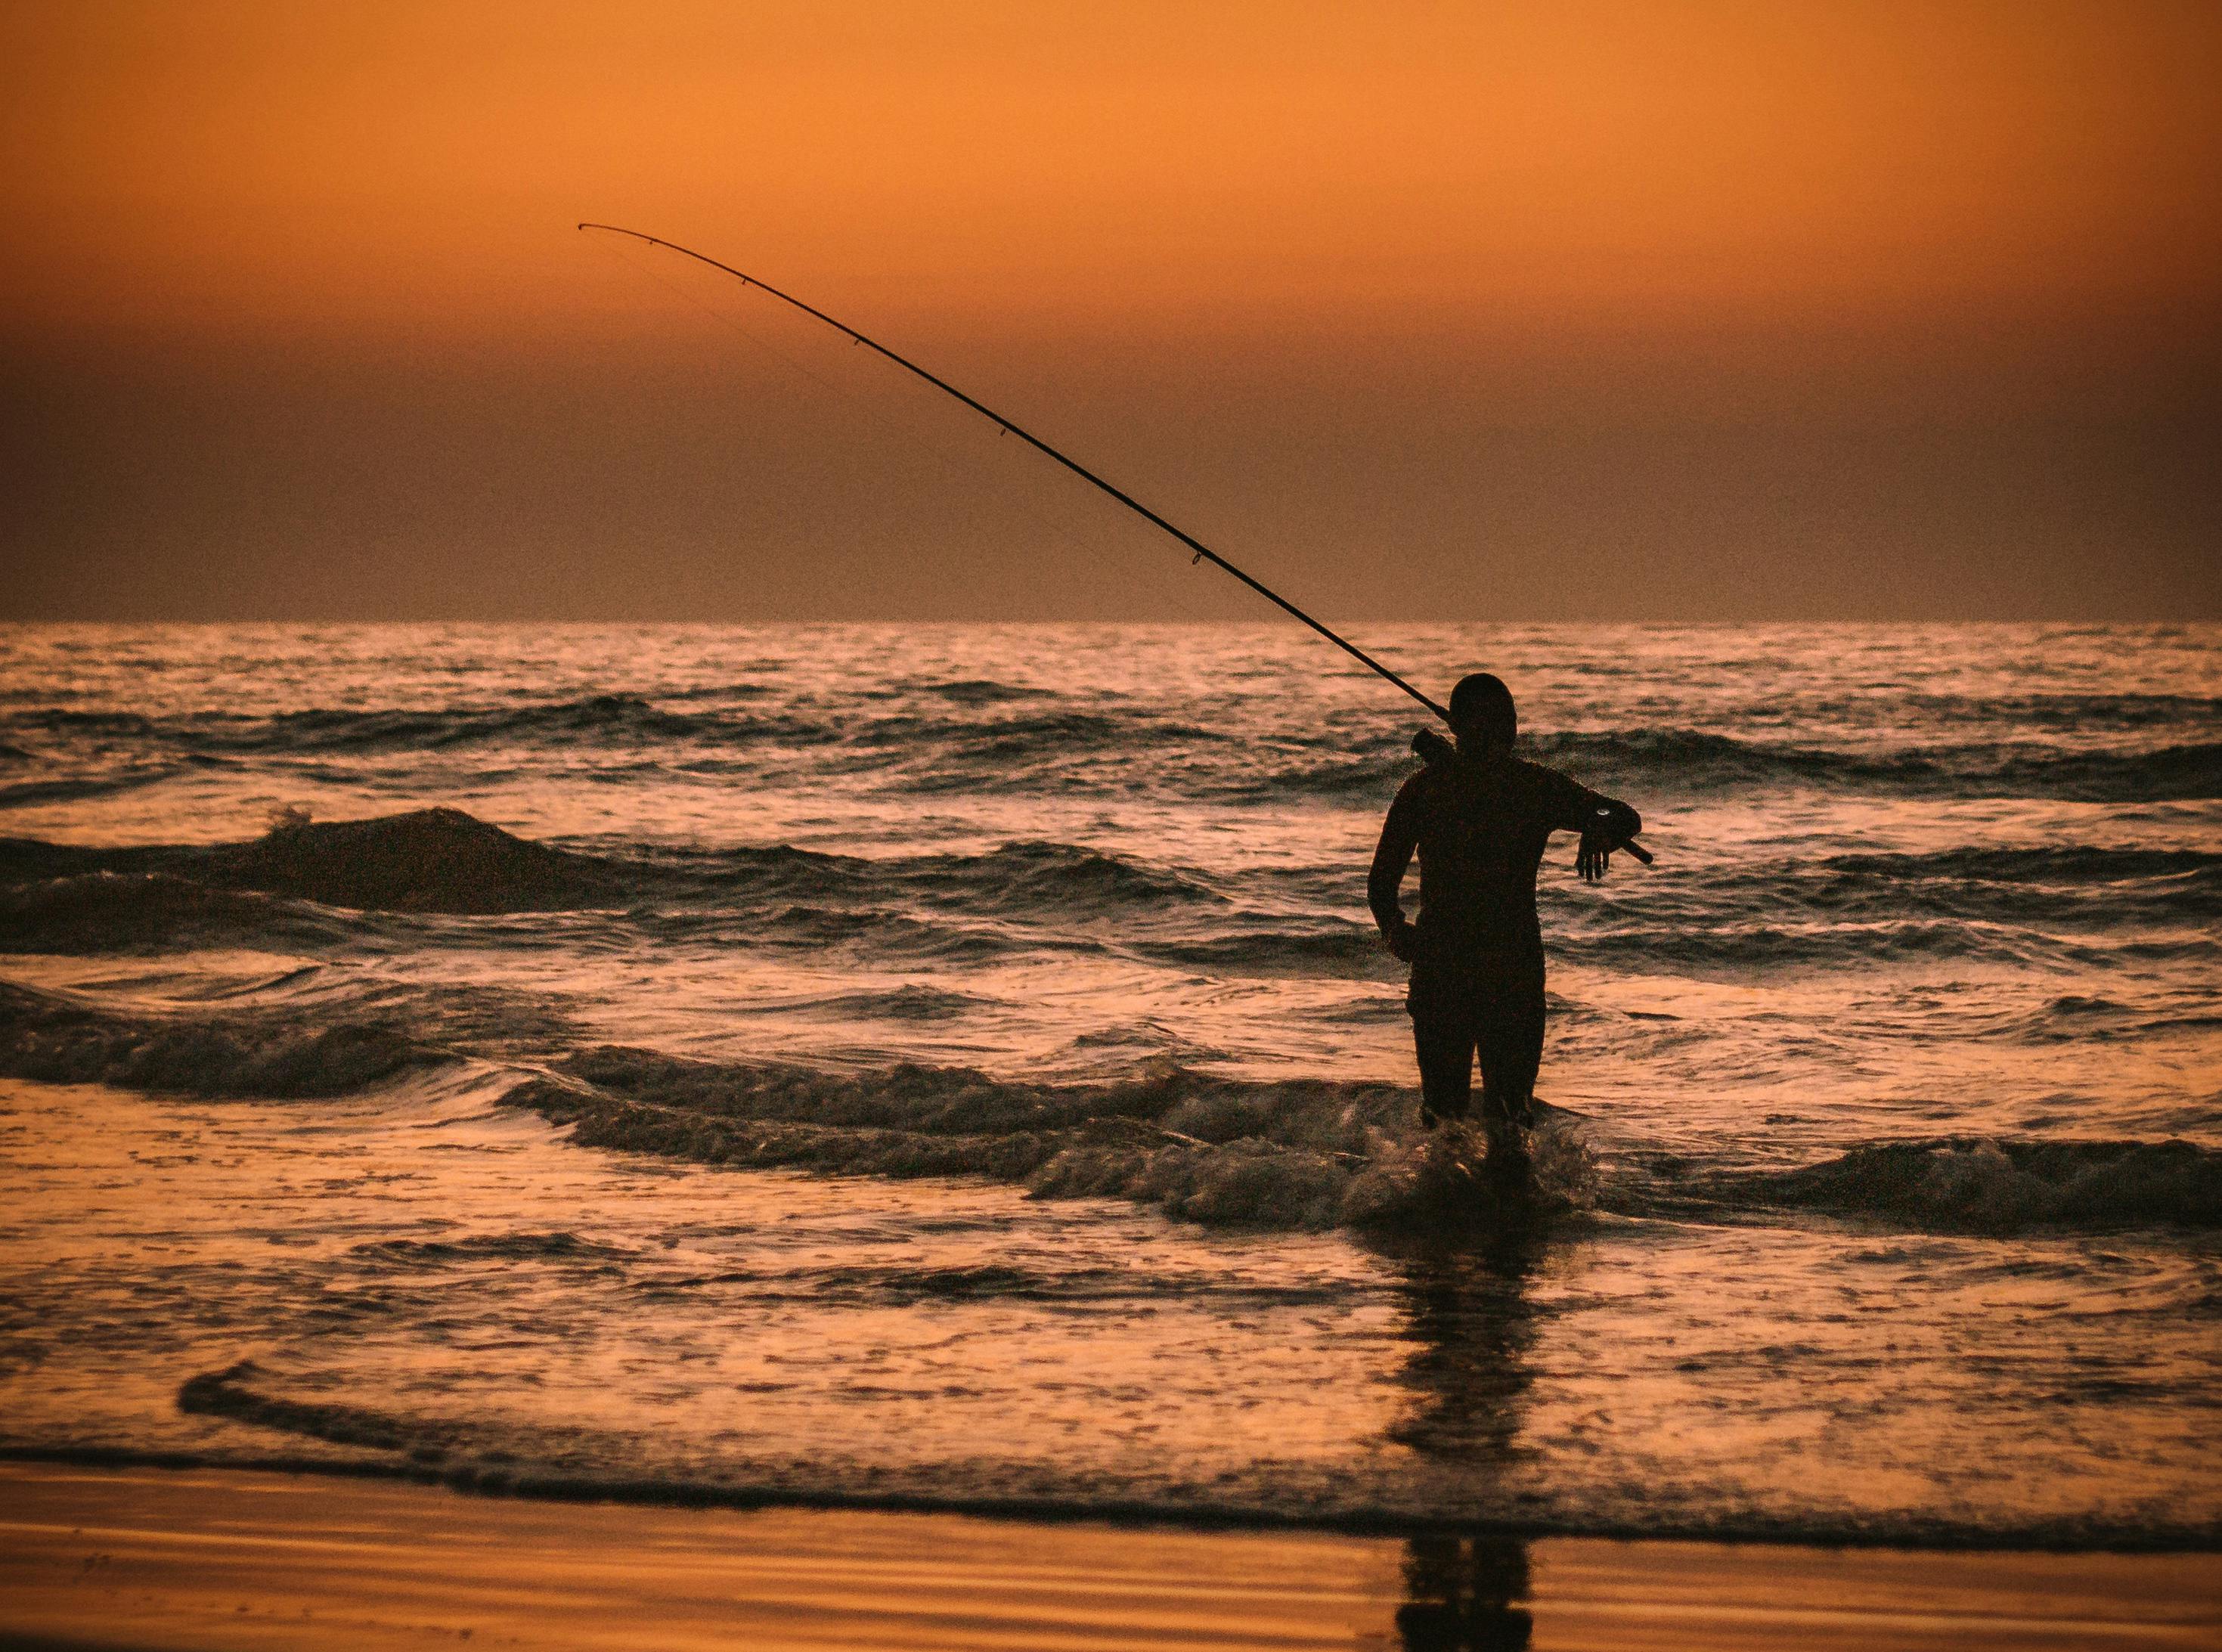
[{"x1": 1391, "y1": 1232, "x2": 1545, "y2": 1652}]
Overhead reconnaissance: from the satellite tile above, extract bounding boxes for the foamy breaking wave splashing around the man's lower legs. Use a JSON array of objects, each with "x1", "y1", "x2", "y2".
[{"x1": 509, "y1": 1047, "x2": 2222, "y2": 1232}]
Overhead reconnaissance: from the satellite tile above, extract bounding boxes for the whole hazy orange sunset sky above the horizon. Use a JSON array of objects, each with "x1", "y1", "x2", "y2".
[{"x1": 0, "y1": 0, "x2": 2222, "y2": 620}]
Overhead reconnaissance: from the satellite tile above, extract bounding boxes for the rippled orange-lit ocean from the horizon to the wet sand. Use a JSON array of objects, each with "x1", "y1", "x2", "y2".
[{"x1": 0, "y1": 625, "x2": 2222, "y2": 1548}]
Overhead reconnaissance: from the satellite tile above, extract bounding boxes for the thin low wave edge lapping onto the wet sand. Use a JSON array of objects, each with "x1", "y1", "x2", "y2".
[{"x1": 143, "y1": 1359, "x2": 2217, "y2": 1550}]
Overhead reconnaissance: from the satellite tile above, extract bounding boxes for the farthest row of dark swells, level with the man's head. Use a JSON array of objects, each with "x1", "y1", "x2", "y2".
[{"x1": 13, "y1": 680, "x2": 2222, "y2": 803}]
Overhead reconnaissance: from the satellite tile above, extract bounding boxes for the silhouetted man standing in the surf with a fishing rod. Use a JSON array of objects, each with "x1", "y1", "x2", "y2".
[{"x1": 1366, "y1": 671, "x2": 1644, "y2": 1170}]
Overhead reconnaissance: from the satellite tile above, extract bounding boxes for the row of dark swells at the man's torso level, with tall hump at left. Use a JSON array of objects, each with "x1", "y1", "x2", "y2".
[{"x1": 0, "y1": 809, "x2": 2222, "y2": 982}]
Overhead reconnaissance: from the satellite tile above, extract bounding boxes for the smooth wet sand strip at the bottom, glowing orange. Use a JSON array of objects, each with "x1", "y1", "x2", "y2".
[{"x1": 0, "y1": 1463, "x2": 2222, "y2": 1652}]
